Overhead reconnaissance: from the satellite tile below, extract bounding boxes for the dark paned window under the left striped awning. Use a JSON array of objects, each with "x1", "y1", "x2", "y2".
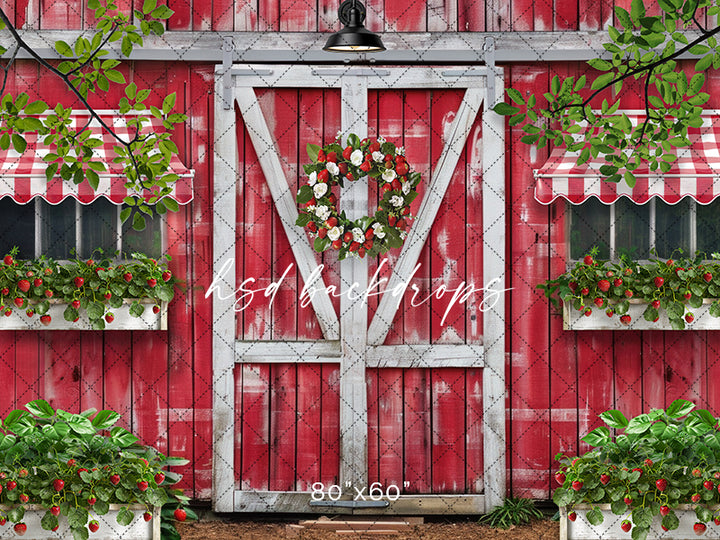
[{"x1": 0, "y1": 197, "x2": 163, "y2": 260}]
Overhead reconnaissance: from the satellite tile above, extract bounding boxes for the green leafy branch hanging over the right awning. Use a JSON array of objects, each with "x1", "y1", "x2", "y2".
[{"x1": 493, "y1": 0, "x2": 720, "y2": 187}]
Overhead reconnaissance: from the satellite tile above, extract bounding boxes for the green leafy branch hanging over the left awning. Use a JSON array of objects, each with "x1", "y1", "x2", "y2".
[{"x1": 0, "y1": 0, "x2": 187, "y2": 228}]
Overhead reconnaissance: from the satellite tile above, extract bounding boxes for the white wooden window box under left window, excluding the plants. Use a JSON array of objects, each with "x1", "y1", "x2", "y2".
[{"x1": 0, "y1": 299, "x2": 168, "y2": 330}]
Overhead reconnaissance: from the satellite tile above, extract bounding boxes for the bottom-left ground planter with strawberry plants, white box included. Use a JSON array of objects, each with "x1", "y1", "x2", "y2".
[{"x1": 0, "y1": 399, "x2": 188, "y2": 540}]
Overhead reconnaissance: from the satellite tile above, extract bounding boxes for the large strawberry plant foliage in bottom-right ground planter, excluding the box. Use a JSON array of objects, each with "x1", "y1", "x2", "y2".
[{"x1": 553, "y1": 399, "x2": 720, "y2": 540}]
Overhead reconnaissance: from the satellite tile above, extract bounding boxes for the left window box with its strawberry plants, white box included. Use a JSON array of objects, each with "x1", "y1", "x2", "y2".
[{"x1": 0, "y1": 249, "x2": 177, "y2": 330}]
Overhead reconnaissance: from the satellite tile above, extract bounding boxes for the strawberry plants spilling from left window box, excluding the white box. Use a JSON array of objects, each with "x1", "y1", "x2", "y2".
[{"x1": 0, "y1": 248, "x2": 177, "y2": 330}]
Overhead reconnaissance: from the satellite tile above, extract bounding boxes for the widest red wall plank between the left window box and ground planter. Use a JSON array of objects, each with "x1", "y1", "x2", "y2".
[{"x1": 38, "y1": 330, "x2": 81, "y2": 413}]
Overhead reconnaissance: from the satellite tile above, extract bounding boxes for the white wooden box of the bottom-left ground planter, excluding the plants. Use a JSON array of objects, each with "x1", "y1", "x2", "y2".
[{"x1": 0, "y1": 504, "x2": 160, "y2": 540}]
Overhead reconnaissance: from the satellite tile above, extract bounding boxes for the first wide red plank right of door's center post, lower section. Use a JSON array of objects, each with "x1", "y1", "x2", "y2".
[{"x1": 378, "y1": 369, "x2": 404, "y2": 489}]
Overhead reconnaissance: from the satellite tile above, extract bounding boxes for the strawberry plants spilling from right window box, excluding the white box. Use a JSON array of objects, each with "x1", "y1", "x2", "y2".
[{"x1": 537, "y1": 248, "x2": 720, "y2": 330}]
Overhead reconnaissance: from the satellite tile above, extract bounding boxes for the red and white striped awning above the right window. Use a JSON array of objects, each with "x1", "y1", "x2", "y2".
[{"x1": 535, "y1": 116, "x2": 720, "y2": 204}]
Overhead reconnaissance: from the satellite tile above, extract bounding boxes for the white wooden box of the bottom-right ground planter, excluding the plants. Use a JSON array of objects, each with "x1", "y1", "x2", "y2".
[{"x1": 560, "y1": 504, "x2": 720, "y2": 540}]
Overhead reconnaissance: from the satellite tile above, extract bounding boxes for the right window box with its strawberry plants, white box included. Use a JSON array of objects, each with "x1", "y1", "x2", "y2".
[{"x1": 538, "y1": 249, "x2": 720, "y2": 330}]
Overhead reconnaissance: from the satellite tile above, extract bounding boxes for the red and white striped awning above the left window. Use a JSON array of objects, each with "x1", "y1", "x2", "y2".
[{"x1": 0, "y1": 112, "x2": 195, "y2": 204}]
